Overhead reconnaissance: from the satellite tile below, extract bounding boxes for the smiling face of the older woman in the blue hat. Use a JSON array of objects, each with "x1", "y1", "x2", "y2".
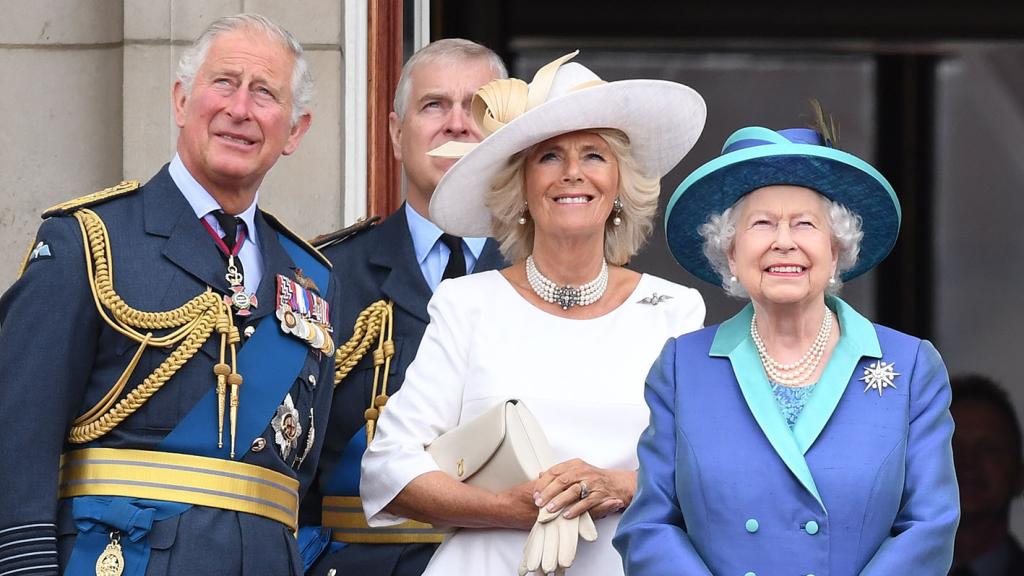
[{"x1": 729, "y1": 186, "x2": 838, "y2": 304}]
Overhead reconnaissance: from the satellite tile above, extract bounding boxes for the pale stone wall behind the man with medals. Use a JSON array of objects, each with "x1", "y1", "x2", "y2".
[{"x1": 0, "y1": 0, "x2": 344, "y2": 291}]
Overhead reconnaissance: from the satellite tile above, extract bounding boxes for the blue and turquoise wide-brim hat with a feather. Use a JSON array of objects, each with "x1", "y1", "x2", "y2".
[{"x1": 665, "y1": 126, "x2": 901, "y2": 286}]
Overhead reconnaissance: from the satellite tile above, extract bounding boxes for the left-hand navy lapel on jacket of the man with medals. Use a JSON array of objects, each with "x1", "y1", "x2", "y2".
[{"x1": 143, "y1": 166, "x2": 228, "y2": 293}]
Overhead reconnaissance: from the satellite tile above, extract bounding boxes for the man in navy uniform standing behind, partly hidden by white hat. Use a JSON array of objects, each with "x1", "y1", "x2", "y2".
[{"x1": 299, "y1": 39, "x2": 507, "y2": 576}]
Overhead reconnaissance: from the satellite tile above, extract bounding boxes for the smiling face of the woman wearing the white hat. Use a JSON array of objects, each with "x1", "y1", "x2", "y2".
[{"x1": 524, "y1": 131, "x2": 618, "y2": 244}]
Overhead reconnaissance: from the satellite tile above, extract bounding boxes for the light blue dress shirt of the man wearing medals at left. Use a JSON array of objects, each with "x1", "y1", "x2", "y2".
[{"x1": 167, "y1": 154, "x2": 263, "y2": 294}]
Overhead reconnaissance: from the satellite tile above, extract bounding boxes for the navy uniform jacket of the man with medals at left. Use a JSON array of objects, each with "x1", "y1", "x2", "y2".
[{"x1": 0, "y1": 166, "x2": 335, "y2": 576}]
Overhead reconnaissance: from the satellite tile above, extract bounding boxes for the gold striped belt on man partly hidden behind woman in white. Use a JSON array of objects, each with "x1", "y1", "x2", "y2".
[{"x1": 321, "y1": 496, "x2": 444, "y2": 544}]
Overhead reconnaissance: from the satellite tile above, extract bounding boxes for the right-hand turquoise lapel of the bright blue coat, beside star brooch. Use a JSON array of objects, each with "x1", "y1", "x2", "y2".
[{"x1": 793, "y1": 298, "x2": 882, "y2": 454}]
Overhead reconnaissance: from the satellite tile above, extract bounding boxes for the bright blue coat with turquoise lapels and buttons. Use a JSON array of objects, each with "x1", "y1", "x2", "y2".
[{"x1": 613, "y1": 299, "x2": 959, "y2": 576}]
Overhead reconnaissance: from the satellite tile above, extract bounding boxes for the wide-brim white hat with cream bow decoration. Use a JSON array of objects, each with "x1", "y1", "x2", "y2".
[{"x1": 430, "y1": 51, "x2": 708, "y2": 237}]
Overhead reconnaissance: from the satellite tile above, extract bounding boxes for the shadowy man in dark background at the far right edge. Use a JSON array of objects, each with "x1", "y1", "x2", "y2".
[{"x1": 949, "y1": 375, "x2": 1024, "y2": 576}]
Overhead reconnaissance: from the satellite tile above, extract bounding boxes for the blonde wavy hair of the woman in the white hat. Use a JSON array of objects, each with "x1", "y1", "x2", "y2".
[{"x1": 484, "y1": 128, "x2": 662, "y2": 265}]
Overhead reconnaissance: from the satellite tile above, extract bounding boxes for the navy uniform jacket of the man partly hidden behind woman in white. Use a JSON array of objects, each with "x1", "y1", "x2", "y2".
[{"x1": 302, "y1": 205, "x2": 505, "y2": 576}]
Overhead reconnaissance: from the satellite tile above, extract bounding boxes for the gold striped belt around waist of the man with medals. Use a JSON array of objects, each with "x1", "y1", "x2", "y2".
[{"x1": 60, "y1": 448, "x2": 299, "y2": 531}]
